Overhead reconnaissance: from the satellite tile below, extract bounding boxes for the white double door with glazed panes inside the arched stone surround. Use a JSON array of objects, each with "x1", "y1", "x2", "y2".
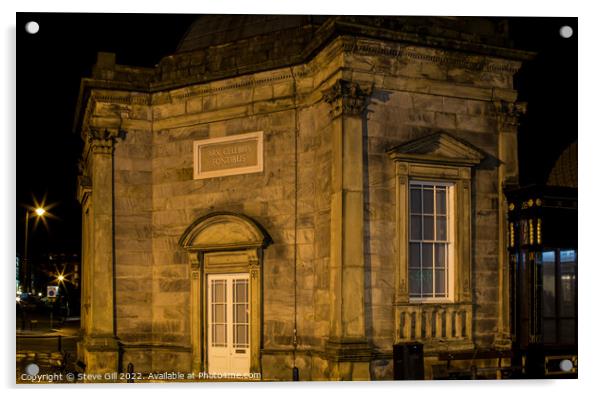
[{"x1": 206, "y1": 273, "x2": 250, "y2": 374}]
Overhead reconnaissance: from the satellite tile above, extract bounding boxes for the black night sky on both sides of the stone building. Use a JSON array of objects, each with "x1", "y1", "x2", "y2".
[{"x1": 16, "y1": 13, "x2": 577, "y2": 259}]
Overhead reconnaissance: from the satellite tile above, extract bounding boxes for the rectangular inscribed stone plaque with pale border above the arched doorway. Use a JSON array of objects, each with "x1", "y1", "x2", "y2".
[{"x1": 194, "y1": 131, "x2": 263, "y2": 179}]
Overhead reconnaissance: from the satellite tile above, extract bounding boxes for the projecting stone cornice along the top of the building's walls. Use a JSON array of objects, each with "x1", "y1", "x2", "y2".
[{"x1": 74, "y1": 24, "x2": 532, "y2": 131}]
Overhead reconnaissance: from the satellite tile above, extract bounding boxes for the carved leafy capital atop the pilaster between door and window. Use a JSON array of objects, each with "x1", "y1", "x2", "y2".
[{"x1": 322, "y1": 79, "x2": 372, "y2": 118}]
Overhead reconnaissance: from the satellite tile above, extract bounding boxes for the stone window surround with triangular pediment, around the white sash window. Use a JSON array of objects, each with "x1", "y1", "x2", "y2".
[{"x1": 387, "y1": 131, "x2": 486, "y2": 306}]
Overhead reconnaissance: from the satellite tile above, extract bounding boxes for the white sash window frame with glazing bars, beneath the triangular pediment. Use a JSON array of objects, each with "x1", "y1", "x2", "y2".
[{"x1": 406, "y1": 178, "x2": 456, "y2": 303}]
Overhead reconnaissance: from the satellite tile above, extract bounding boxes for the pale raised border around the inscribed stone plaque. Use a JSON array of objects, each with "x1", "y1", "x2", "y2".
[{"x1": 193, "y1": 131, "x2": 263, "y2": 179}]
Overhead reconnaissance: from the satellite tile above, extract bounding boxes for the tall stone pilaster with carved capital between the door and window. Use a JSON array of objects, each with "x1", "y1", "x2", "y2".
[{"x1": 323, "y1": 80, "x2": 371, "y2": 379}]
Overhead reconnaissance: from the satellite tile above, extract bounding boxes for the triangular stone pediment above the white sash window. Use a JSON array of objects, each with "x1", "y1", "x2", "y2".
[{"x1": 387, "y1": 132, "x2": 485, "y2": 166}]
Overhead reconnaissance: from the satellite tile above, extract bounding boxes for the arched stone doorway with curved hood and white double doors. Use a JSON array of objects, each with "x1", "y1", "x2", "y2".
[{"x1": 180, "y1": 212, "x2": 271, "y2": 373}]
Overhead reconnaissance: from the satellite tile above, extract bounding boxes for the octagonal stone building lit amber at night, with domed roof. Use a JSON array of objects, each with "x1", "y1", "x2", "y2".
[{"x1": 75, "y1": 15, "x2": 531, "y2": 380}]
